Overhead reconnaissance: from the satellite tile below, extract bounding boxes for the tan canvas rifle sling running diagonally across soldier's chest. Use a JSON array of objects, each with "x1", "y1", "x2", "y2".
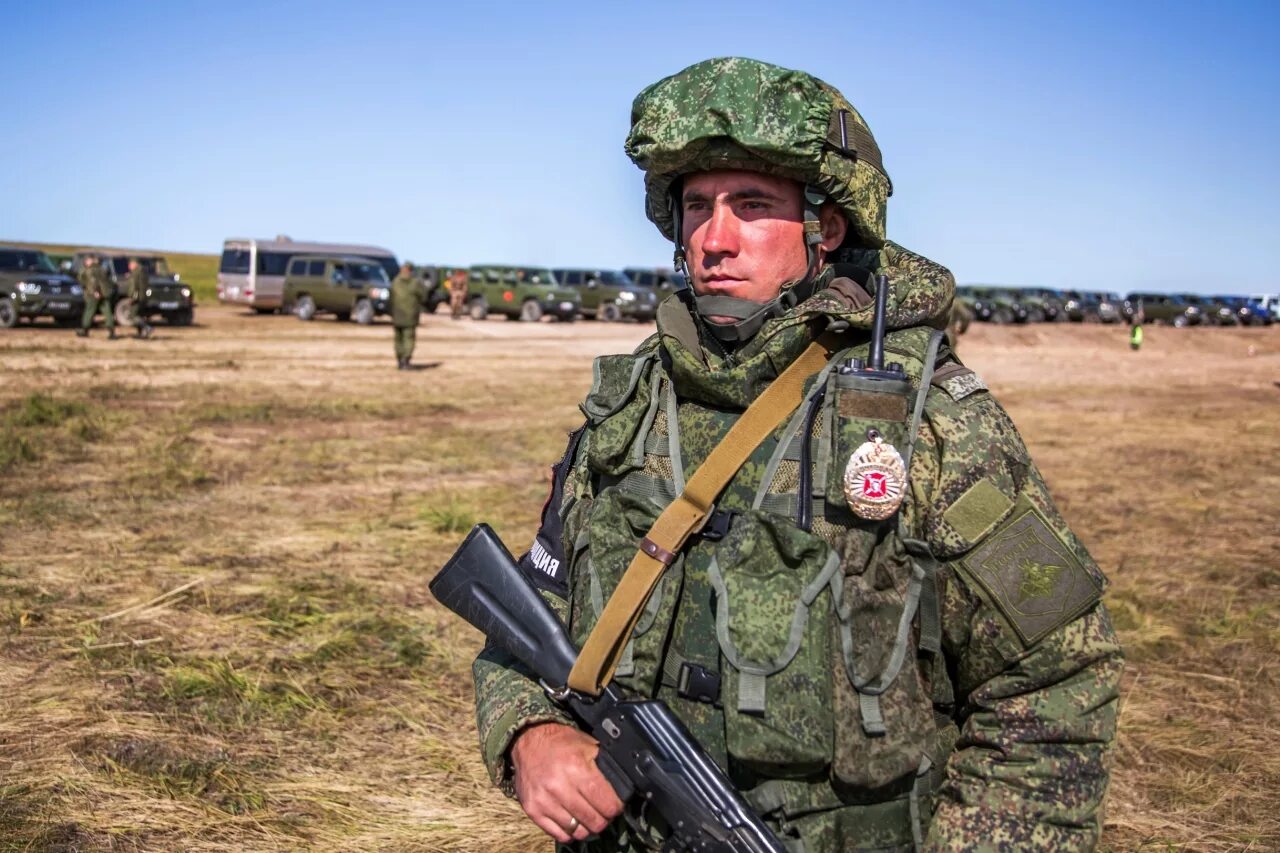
[{"x1": 568, "y1": 327, "x2": 837, "y2": 695}]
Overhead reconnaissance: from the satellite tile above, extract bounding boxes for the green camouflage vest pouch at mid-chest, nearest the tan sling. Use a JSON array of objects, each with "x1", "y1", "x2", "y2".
[{"x1": 708, "y1": 510, "x2": 840, "y2": 777}]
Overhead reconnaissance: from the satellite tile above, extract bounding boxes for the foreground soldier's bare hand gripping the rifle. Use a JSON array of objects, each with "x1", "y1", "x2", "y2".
[{"x1": 511, "y1": 722, "x2": 622, "y2": 844}]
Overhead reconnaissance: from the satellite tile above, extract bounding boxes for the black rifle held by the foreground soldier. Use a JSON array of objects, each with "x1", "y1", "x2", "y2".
[{"x1": 430, "y1": 524, "x2": 783, "y2": 853}]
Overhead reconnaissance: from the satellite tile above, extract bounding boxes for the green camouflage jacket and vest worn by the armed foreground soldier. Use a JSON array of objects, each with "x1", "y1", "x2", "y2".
[{"x1": 475, "y1": 243, "x2": 1121, "y2": 853}]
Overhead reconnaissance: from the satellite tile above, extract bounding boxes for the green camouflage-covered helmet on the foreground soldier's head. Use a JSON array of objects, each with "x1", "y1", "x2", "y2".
[{"x1": 626, "y1": 58, "x2": 893, "y2": 248}]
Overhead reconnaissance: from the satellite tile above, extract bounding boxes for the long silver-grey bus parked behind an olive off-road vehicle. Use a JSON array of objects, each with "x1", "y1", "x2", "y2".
[{"x1": 218, "y1": 236, "x2": 399, "y2": 314}]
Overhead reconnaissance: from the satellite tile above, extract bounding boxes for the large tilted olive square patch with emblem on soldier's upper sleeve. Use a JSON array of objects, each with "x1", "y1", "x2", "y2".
[{"x1": 960, "y1": 497, "x2": 1102, "y2": 648}]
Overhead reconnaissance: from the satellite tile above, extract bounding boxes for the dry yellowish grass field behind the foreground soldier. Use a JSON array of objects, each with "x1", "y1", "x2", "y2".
[{"x1": 0, "y1": 302, "x2": 1280, "y2": 853}]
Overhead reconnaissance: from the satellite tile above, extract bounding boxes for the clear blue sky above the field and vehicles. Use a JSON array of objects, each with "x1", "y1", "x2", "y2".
[{"x1": 0, "y1": 0, "x2": 1280, "y2": 292}]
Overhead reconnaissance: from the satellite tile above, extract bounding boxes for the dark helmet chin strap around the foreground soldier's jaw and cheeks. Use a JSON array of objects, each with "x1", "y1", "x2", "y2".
[{"x1": 671, "y1": 184, "x2": 827, "y2": 348}]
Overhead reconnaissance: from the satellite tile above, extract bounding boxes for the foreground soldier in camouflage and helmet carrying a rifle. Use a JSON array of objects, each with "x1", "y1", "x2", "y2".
[{"x1": 475, "y1": 59, "x2": 1121, "y2": 853}]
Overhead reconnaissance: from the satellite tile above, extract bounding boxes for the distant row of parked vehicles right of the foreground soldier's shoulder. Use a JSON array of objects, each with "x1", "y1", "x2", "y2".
[{"x1": 956, "y1": 284, "x2": 1280, "y2": 327}]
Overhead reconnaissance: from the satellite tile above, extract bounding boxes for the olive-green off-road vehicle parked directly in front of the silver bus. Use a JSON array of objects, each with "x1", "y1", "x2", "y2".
[{"x1": 282, "y1": 255, "x2": 392, "y2": 325}]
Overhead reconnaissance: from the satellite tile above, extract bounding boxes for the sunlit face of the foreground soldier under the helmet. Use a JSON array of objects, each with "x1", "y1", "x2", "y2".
[{"x1": 681, "y1": 169, "x2": 845, "y2": 308}]
